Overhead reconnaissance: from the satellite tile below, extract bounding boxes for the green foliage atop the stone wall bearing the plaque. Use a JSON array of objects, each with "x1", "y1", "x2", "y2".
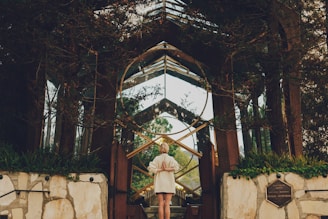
[{"x1": 229, "y1": 153, "x2": 328, "y2": 179}]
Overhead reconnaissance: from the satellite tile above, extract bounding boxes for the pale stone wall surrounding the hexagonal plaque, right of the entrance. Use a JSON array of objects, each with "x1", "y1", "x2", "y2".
[{"x1": 221, "y1": 173, "x2": 328, "y2": 219}]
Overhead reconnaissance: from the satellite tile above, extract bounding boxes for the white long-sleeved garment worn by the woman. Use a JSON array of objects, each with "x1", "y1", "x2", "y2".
[{"x1": 148, "y1": 153, "x2": 180, "y2": 194}]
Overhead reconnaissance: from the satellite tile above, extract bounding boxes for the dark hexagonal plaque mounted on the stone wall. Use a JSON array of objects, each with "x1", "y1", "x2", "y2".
[{"x1": 266, "y1": 180, "x2": 292, "y2": 208}]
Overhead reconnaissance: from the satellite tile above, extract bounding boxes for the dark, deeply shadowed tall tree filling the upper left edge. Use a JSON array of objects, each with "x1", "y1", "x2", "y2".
[{"x1": 0, "y1": 1, "x2": 45, "y2": 152}]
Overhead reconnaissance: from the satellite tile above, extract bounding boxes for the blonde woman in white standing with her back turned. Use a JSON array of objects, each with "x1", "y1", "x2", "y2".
[{"x1": 148, "y1": 142, "x2": 179, "y2": 219}]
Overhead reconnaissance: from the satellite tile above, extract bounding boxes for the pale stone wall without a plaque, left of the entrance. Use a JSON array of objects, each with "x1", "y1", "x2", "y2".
[{"x1": 0, "y1": 171, "x2": 108, "y2": 219}]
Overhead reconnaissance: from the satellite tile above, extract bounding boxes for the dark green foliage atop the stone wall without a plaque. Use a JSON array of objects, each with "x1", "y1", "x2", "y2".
[{"x1": 0, "y1": 144, "x2": 101, "y2": 176}]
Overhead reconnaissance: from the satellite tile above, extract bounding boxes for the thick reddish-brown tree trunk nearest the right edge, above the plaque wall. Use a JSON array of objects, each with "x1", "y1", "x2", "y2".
[{"x1": 274, "y1": 1, "x2": 303, "y2": 156}]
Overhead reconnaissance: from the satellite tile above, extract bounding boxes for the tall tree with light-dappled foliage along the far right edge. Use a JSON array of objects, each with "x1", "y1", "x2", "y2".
[{"x1": 301, "y1": 0, "x2": 328, "y2": 160}]
